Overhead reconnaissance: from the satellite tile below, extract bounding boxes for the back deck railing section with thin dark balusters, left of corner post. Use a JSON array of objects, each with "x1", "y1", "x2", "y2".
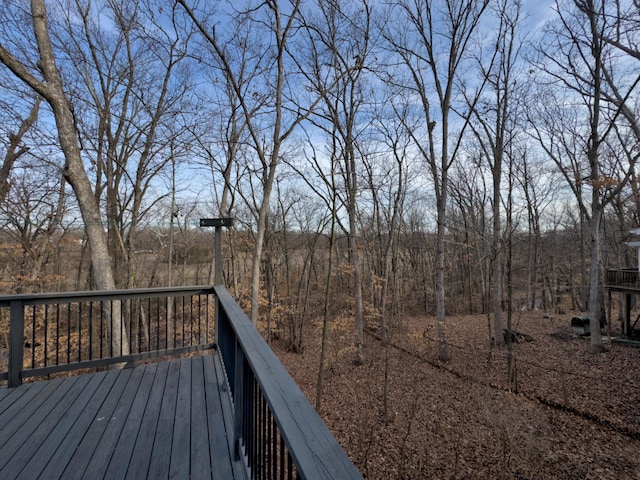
[{"x1": 0, "y1": 287, "x2": 215, "y2": 387}]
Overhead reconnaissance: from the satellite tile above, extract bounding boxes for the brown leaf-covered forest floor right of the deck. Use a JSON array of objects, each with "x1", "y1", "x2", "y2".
[{"x1": 273, "y1": 312, "x2": 640, "y2": 480}]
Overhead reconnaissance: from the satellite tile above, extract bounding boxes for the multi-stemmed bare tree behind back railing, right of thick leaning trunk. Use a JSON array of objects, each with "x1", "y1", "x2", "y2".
[{"x1": 59, "y1": 0, "x2": 199, "y2": 287}]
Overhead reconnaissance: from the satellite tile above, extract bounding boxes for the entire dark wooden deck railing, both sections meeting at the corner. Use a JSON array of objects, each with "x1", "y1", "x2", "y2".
[{"x1": 0, "y1": 286, "x2": 362, "y2": 479}]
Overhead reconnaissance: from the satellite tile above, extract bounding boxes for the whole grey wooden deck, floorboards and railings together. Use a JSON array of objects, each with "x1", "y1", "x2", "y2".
[{"x1": 0, "y1": 286, "x2": 362, "y2": 480}]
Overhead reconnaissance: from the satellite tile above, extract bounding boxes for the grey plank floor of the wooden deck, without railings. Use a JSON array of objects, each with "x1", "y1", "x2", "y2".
[{"x1": 0, "y1": 352, "x2": 242, "y2": 480}]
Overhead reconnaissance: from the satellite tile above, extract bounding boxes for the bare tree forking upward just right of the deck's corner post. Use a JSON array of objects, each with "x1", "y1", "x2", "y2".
[{"x1": 177, "y1": 0, "x2": 332, "y2": 322}]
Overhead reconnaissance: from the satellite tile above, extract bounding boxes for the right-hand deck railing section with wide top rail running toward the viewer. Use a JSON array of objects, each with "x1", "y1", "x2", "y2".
[{"x1": 214, "y1": 286, "x2": 362, "y2": 480}]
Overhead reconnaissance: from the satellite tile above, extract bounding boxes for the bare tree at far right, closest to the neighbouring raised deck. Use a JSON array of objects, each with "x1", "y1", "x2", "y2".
[{"x1": 534, "y1": 0, "x2": 635, "y2": 353}]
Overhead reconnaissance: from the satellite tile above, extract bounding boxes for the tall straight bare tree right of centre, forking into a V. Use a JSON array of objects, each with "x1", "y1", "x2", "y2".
[{"x1": 386, "y1": 0, "x2": 489, "y2": 361}]
